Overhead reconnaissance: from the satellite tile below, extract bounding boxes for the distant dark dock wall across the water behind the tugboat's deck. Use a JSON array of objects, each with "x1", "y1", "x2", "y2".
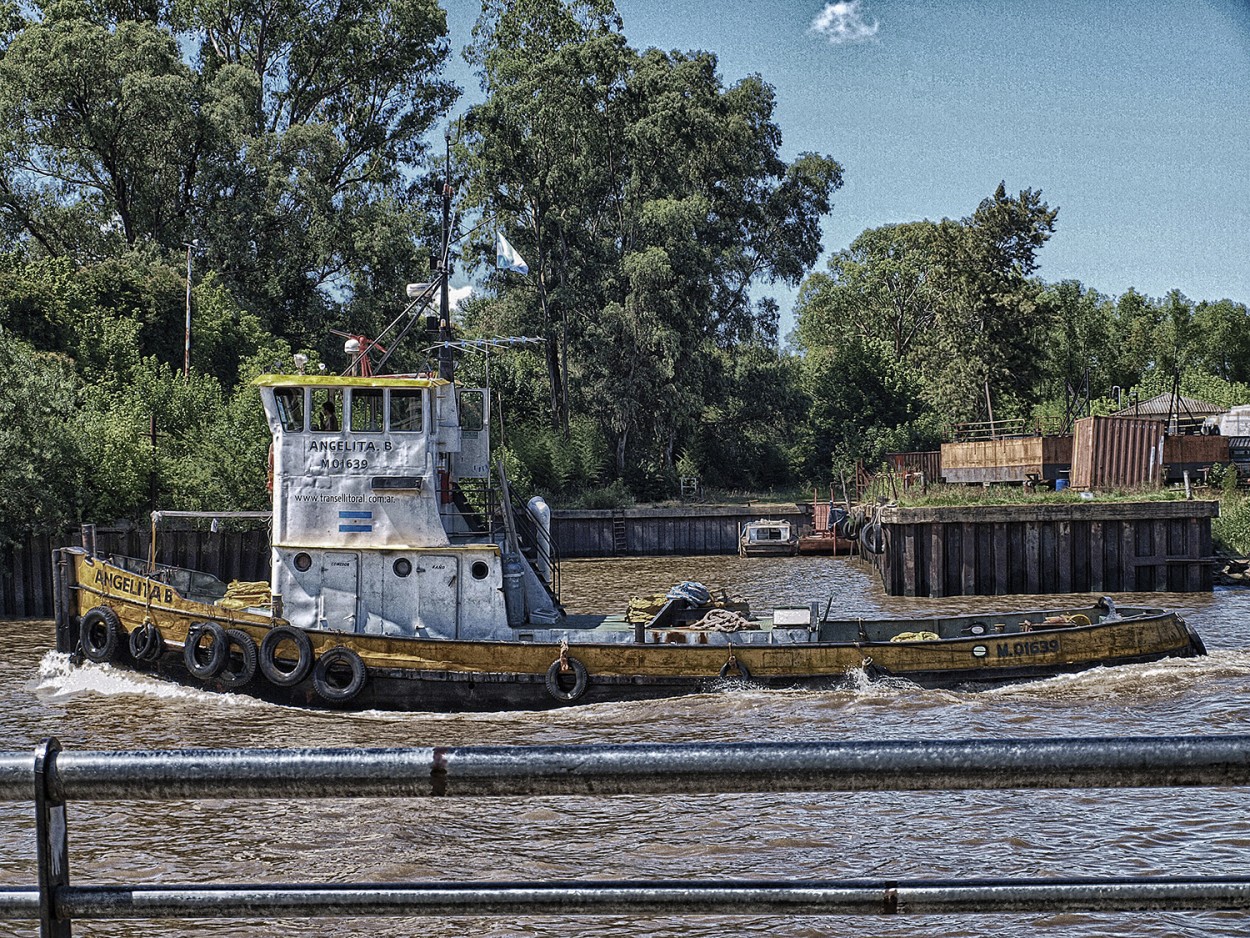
[{"x1": 551, "y1": 502, "x2": 813, "y2": 557}]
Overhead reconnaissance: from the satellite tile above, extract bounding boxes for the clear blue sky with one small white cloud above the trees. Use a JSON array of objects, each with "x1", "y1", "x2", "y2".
[{"x1": 444, "y1": 0, "x2": 1250, "y2": 334}]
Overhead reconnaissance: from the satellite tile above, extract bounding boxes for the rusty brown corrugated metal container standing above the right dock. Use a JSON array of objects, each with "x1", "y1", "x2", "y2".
[{"x1": 1071, "y1": 416, "x2": 1164, "y2": 489}]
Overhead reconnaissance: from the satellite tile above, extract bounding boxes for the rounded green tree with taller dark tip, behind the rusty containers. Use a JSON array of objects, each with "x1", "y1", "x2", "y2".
[{"x1": 796, "y1": 184, "x2": 1058, "y2": 440}]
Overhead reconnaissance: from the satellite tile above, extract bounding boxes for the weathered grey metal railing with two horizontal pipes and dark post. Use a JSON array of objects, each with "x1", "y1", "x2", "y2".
[{"x1": 0, "y1": 735, "x2": 1250, "y2": 938}]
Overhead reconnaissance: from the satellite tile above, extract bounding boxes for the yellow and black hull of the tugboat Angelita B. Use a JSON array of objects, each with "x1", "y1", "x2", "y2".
[{"x1": 58, "y1": 550, "x2": 1205, "y2": 712}]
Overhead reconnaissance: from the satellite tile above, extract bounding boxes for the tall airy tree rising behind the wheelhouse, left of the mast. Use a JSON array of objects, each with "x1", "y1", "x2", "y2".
[{"x1": 180, "y1": 0, "x2": 458, "y2": 343}]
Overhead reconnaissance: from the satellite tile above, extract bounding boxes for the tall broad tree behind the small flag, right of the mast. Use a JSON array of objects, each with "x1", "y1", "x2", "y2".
[{"x1": 464, "y1": 0, "x2": 841, "y2": 485}]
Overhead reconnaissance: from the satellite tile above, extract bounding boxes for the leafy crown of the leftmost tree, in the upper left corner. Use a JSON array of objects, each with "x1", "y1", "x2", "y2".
[{"x1": 0, "y1": 9, "x2": 208, "y2": 259}]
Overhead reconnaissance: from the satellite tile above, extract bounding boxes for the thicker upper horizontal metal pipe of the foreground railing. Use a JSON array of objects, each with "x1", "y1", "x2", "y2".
[{"x1": 0, "y1": 735, "x2": 1250, "y2": 802}]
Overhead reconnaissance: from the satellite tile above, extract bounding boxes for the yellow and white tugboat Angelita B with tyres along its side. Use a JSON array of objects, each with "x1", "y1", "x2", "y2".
[{"x1": 44, "y1": 161, "x2": 1204, "y2": 710}]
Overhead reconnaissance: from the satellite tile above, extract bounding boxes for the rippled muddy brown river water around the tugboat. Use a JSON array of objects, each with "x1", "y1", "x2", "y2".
[{"x1": 0, "y1": 557, "x2": 1250, "y2": 938}]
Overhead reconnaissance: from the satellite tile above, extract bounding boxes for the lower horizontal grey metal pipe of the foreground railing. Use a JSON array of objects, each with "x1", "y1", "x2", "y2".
[{"x1": 0, "y1": 877, "x2": 1250, "y2": 920}]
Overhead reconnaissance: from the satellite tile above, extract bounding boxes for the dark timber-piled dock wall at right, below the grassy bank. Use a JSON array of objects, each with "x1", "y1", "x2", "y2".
[{"x1": 868, "y1": 502, "x2": 1219, "y2": 597}]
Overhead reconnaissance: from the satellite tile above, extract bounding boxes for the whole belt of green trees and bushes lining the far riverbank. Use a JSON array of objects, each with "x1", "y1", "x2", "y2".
[{"x1": 0, "y1": 0, "x2": 1250, "y2": 547}]
